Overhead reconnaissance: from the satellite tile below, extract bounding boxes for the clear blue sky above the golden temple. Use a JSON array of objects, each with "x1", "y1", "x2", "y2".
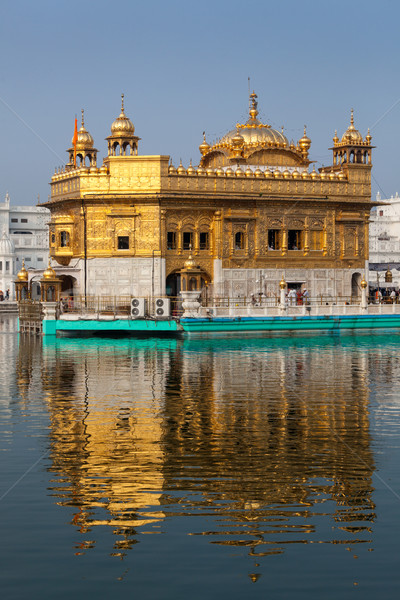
[{"x1": 0, "y1": 0, "x2": 400, "y2": 204}]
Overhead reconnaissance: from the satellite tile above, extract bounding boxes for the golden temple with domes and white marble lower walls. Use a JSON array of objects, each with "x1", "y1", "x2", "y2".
[{"x1": 44, "y1": 92, "x2": 373, "y2": 297}]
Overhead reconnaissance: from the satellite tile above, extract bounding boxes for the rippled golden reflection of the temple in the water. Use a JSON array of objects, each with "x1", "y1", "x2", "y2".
[{"x1": 17, "y1": 338, "x2": 375, "y2": 556}]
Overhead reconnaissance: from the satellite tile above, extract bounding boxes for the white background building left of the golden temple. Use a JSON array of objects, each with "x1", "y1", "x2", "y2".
[{"x1": 0, "y1": 193, "x2": 50, "y2": 299}]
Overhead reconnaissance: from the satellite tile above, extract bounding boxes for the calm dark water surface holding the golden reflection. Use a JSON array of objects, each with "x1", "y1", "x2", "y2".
[{"x1": 0, "y1": 317, "x2": 400, "y2": 600}]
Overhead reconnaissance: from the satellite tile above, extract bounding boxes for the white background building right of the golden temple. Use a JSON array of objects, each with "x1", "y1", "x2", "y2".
[{"x1": 369, "y1": 192, "x2": 400, "y2": 287}]
